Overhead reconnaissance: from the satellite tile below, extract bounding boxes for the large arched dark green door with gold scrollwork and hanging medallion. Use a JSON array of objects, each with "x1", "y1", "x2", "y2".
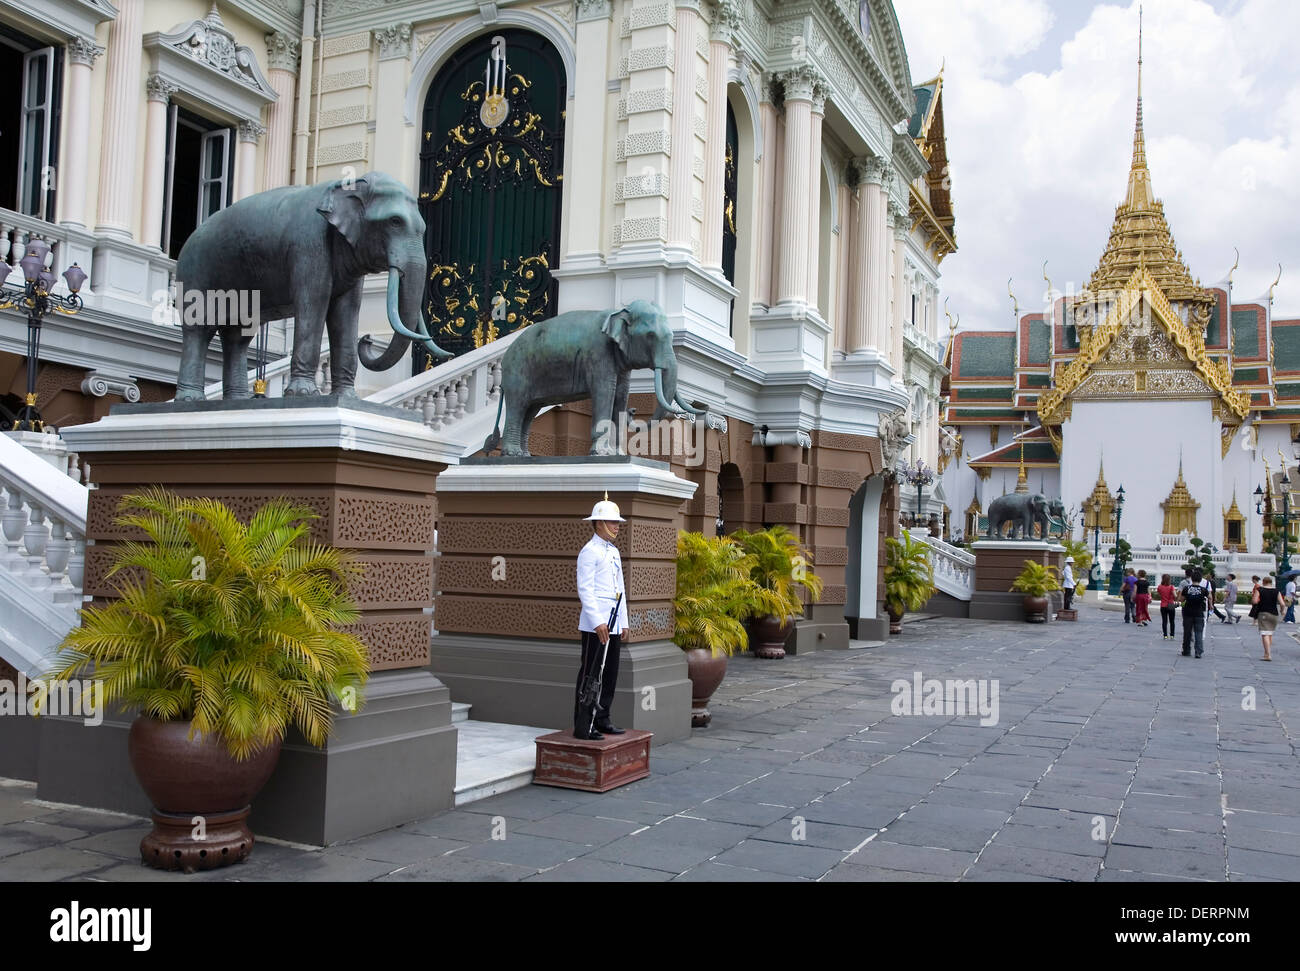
[{"x1": 412, "y1": 30, "x2": 564, "y2": 372}]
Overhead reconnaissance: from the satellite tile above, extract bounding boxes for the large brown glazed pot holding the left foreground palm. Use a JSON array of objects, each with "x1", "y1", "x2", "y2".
[{"x1": 126, "y1": 715, "x2": 281, "y2": 874}]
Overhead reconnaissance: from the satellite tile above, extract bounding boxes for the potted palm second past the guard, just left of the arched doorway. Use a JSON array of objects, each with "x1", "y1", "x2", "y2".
[{"x1": 732, "y1": 525, "x2": 822, "y2": 659}]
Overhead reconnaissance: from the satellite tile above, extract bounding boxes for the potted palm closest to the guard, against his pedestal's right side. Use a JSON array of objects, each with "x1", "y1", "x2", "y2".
[{"x1": 672, "y1": 532, "x2": 775, "y2": 728}]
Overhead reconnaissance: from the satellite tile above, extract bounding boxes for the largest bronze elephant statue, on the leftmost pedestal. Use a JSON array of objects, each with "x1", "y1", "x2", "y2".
[{"x1": 176, "y1": 173, "x2": 452, "y2": 402}]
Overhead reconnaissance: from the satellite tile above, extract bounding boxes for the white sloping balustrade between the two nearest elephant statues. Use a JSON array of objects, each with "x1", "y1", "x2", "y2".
[{"x1": 367, "y1": 330, "x2": 523, "y2": 432}]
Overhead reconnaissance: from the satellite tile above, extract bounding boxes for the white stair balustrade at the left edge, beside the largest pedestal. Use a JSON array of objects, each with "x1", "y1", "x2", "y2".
[{"x1": 0, "y1": 434, "x2": 90, "y2": 673}]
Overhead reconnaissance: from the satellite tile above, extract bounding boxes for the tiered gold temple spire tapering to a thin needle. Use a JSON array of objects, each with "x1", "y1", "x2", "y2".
[{"x1": 1088, "y1": 27, "x2": 1214, "y2": 304}]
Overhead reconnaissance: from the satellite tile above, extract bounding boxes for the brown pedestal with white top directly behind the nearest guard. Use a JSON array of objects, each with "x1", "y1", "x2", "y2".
[{"x1": 430, "y1": 455, "x2": 697, "y2": 745}]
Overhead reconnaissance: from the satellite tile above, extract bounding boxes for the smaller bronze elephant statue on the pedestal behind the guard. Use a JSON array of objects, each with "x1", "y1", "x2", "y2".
[{"x1": 484, "y1": 300, "x2": 705, "y2": 455}]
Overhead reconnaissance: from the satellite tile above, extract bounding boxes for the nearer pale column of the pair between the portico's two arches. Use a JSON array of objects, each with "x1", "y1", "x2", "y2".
[{"x1": 776, "y1": 68, "x2": 815, "y2": 304}]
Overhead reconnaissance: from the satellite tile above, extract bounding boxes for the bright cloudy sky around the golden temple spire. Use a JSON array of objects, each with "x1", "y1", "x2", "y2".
[{"x1": 894, "y1": 0, "x2": 1300, "y2": 330}]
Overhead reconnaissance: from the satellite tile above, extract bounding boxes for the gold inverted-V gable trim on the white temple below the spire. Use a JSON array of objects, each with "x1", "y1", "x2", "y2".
[{"x1": 1039, "y1": 265, "x2": 1251, "y2": 425}]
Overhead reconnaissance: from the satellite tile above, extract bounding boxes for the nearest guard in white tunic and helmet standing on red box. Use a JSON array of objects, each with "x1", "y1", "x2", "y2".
[{"x1": 573, "y1": 494, "x2": 628, "y2": 738}]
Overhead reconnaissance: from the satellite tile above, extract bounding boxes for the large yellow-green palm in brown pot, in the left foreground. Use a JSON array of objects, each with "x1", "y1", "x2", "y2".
[{"x1": 41, "y1": 489, "x2": 368, "y2": 872}]
